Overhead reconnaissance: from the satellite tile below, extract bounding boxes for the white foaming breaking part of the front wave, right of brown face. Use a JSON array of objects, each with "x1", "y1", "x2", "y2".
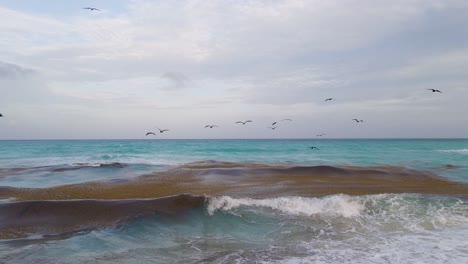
[{"x1": 206, "y1": 194, "x2": 468, "y2": 232}]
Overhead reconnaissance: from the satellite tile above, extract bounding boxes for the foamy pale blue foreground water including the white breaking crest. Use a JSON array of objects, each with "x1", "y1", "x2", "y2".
[{"x1": 0, "y1": 194, "x2": 468, "y2": 263}]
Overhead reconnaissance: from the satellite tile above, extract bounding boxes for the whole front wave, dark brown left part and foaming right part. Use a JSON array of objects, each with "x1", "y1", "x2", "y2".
[{"x1": 0, "y1": 194, "x2": 468, "y2": 239}]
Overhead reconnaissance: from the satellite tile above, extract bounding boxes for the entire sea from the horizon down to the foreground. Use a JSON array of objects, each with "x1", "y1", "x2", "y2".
[{"x1": 0, "y1": 138, "x2": 468, "y2": 264}]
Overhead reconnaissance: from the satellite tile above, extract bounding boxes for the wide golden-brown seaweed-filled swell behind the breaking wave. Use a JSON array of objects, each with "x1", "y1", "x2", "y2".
[{"x1": 0, "y1": 161, "x2": 468, "y2": 200}]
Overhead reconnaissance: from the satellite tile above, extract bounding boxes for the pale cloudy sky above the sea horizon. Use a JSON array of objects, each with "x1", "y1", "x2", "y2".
[{"x1": 0, "y1": 0, "x2": 468, "y2": 139}]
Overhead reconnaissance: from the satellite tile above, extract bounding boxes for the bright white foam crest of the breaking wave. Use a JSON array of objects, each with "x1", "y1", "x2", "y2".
[{"x1": 207, "y1": 194, "x2": 364, "y2": 217}]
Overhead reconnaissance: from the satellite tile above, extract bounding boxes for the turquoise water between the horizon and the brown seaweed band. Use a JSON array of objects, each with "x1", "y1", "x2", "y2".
[{"x1": 0, "y1": 139, "x2": 468, "y2": 187}]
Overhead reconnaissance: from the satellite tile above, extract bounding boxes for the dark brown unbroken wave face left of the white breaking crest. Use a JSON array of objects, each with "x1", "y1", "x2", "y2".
[{"x1": 0, "y1": 195, "x2": 205, "y2": 239}]
